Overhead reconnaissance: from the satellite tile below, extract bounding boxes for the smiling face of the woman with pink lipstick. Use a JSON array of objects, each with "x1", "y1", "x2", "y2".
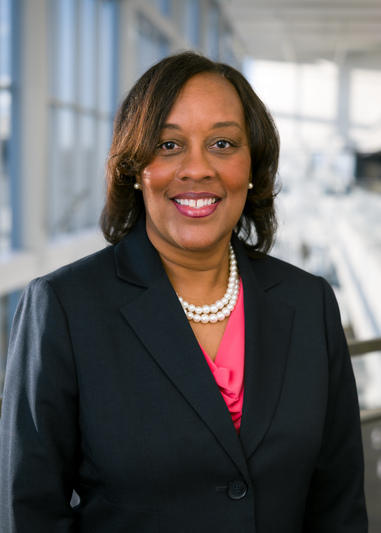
[{"x1": 137, "y1": 73, "x2": 251, "y2": 255}]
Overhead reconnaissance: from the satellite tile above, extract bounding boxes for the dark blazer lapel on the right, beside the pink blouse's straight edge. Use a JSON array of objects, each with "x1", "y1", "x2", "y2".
[{"x1": 235, "y1": 239, "x2": 294, "y2": 459}]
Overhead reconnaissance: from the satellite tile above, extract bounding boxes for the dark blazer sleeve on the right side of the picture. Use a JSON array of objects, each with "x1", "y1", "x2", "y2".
[{"x1": 303, "y1": 280, "x2": 368, "y2": 533}]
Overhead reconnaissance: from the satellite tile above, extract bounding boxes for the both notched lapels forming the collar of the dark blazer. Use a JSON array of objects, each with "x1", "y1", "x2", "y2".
[{"x1": 115, "y1": 217, "x2": 293, "y2": 476}]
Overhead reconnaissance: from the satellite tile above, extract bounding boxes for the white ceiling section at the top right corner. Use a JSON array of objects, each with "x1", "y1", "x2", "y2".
[{"x1": 220, "y1": 0, "x2": 381, "y2": 63}]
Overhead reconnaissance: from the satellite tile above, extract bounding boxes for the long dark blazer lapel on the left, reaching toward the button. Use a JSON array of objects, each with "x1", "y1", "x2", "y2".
[{"x1": 115, "y1": 219, "x2": 250, "y2": 483}]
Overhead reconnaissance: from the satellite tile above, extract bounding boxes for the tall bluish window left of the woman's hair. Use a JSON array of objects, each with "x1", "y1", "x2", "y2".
[{"x1": 48, "y1": 0, "x2": 118, "y2": 237}]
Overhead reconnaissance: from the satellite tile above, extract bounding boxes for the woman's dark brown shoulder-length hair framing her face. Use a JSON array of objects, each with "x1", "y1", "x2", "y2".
[{"x1": 100, "y1": 52, "x2": 279, "y2": 255}]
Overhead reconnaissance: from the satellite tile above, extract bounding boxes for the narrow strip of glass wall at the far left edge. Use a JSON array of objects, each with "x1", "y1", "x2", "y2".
[{"x1": 0, "y1": 0, "x2": 12, "y2": 254}]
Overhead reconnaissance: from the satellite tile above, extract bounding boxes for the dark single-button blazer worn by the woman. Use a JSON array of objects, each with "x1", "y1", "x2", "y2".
[{"x1": 0, "y1": 220, "x2": 367, "y2": 533}]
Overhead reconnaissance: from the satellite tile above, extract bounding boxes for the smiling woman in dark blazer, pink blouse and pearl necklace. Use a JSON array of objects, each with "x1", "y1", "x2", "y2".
[{"x1": 0, "y1": 52, "x2": 367, "y2": 533}]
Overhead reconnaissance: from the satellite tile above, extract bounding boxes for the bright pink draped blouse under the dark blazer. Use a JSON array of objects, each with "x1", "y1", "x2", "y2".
[{"x1": 200, "y1": 280, "x2": 245, "y2": 432}]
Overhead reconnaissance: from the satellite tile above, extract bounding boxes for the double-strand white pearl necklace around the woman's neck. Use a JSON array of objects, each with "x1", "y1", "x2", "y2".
[{"x1": 177, "y1": 244, "x2": 239, "y2": 324}]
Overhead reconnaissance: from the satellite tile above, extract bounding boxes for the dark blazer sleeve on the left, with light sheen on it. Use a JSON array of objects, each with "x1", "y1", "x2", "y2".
[{"x1": 0, "y1": 278, "x2": 79, "y2": 533}]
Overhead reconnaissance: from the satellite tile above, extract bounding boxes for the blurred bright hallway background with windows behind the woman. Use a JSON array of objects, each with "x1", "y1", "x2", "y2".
[{"x1": 0, "y1": 0, "x2": 381, "y2": 533}]
